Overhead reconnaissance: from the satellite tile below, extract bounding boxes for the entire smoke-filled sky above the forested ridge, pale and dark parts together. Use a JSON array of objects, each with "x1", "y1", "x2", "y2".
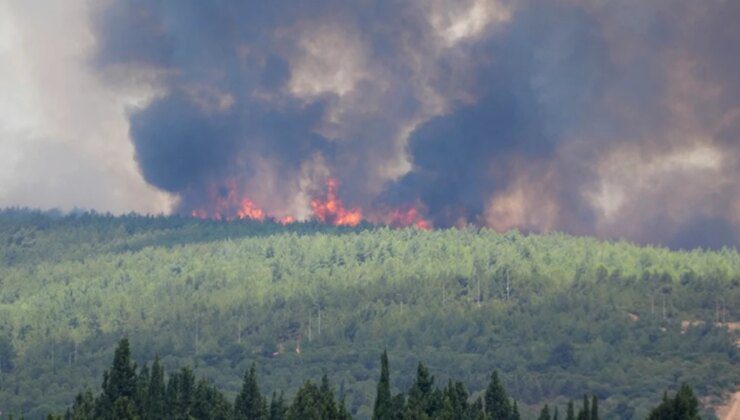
[{"x1": 0, "y1": 0, "x2": 740, "y2": 248}]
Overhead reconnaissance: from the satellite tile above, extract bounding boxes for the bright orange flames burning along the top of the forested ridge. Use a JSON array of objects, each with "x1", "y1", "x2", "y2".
[{"x1": 190, "y1": 178, "x2": 431, "y2": 230}]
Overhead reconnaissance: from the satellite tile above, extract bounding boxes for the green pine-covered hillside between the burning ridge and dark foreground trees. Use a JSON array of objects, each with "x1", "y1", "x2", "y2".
[{"x1": 0, "y1": 210, "x2": 740, "y2": 419}]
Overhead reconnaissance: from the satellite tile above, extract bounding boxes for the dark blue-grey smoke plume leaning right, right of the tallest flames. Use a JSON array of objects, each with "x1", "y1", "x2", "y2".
[{"x1": 390, "y1": 1, "x2": 609, "y2": 226}]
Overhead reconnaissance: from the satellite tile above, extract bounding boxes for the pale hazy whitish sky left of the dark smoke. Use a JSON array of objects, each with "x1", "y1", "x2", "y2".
[{"x1": 0, "y1": 0, "x2": 170, "y2": 212}]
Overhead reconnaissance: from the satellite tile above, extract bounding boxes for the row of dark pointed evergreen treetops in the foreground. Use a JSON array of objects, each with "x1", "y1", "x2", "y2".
[{"x1": 34, "y1": 338, "x2": 700, "y2": 420}]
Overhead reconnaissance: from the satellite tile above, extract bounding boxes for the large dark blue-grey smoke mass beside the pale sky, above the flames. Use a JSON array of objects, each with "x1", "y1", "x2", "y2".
[{"x1": 94, "y1": 1, "x2": 440, "y2": 211}]
